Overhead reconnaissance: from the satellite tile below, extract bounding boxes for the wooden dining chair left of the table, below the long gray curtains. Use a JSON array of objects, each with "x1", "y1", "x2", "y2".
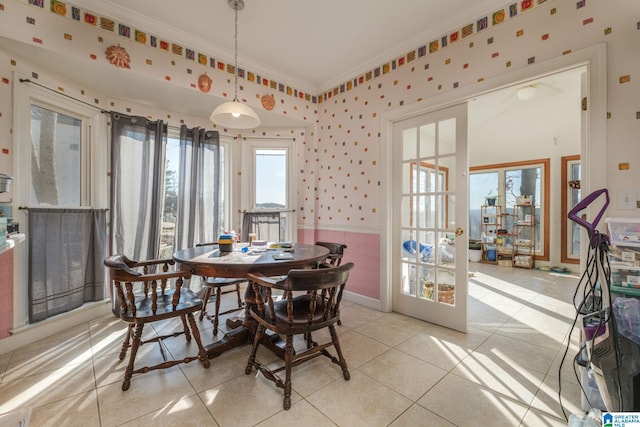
[{"x1": 104, "y1": 254, "x2": 210, "y2": 391}]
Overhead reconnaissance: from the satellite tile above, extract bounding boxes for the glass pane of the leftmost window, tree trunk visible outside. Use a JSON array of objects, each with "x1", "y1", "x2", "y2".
[{"x1": 30, "y1": 105, "x2": 82, "y2": 206}]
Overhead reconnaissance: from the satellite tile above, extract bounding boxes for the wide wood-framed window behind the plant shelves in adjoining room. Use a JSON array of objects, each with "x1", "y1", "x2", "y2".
[{"x1": 469, "y1": 159, "x2": 550, "y2": 260}]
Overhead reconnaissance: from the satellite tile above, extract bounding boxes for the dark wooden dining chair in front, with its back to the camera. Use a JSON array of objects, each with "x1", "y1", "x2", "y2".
[{"x1": 245, "y1": 262, "x2": 353, "y2": 409}]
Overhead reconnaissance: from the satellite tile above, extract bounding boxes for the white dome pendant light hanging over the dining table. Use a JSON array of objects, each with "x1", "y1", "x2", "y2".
[{"x1": 209, "y1": 0, "x2": 260, "y2": 129}]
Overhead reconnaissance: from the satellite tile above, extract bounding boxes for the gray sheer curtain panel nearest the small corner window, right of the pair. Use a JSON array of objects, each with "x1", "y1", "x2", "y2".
[{"x1": 175, "y1": 125, "x2": 221, "y2": 250}]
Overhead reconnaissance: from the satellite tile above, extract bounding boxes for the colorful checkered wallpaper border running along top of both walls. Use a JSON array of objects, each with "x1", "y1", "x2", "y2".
[{"x1": 20, "y1": 0, "x2": 560, "y2": 104}]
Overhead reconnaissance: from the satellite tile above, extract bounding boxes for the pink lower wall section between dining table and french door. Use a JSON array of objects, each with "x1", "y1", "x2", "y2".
[{"x1": 298, "y1": 230, "x2": 380, "y2": 300}]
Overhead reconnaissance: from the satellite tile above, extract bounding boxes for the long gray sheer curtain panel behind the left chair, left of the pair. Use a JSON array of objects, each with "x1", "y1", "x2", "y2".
[{"x1": 111, "y1": 112, "x2": 167, "y2": 260}]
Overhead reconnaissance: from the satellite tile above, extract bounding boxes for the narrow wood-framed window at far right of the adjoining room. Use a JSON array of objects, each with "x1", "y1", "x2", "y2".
[{"x1": 560, "y1": 156, "x2": 581, "y2": 264}]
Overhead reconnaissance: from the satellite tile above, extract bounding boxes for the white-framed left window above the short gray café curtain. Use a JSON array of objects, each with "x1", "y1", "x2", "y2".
[{"x1": 13, "y1": 76, "x2": 108, "y2": 208}]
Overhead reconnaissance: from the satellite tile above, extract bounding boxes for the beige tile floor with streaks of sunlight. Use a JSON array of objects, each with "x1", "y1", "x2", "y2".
[{"x1": 0, "y1": 263, "x2": 581, "y2": 427}]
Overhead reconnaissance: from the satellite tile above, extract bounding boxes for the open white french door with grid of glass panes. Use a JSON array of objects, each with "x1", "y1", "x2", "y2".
[{"x1": 391, "y1": 103, "x2": 469, "y2": 332}]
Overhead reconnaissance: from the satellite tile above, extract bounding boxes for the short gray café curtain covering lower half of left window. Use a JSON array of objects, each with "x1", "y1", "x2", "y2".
[{"x1": 28, "y1": 208, "x2": 107, "y2": 323}]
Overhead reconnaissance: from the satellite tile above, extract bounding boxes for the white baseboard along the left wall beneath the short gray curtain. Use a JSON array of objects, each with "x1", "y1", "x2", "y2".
[{"x1": 0, "y1": 299, "x2": 111, "y2": 354}]
